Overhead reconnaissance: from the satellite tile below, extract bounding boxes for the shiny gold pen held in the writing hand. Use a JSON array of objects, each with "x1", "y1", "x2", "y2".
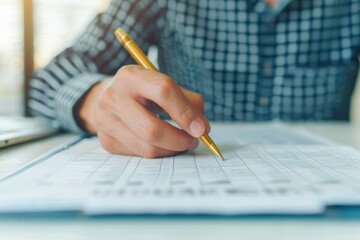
[{"x1": 115, "y1": 28, "x2": 225, "y2": 160}]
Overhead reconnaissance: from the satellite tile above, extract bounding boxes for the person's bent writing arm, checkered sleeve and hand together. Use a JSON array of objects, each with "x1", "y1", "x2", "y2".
[{"x1": 29, "y1": 0, "x2": 210, "y2": 158}]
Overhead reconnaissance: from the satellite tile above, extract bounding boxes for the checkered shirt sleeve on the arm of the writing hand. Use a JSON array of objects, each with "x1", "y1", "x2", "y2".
[{"x1": 28, "y1": 0, "x2": 160, "y2": 133}]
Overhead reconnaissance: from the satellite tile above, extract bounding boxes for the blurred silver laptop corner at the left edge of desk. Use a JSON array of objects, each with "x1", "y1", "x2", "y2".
[{"x1": 0, "y1": 116, "x2": 58, "y2": 148}]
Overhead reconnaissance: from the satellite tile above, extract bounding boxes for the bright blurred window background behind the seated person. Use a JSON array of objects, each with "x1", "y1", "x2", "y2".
[{"x1": 0, "y1": 0, "x2": 360, "y2": 123}]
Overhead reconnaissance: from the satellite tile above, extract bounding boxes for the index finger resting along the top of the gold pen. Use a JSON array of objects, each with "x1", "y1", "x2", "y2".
[{"x1": 119, "y1": 66, "x2": 209, "y2": 138}]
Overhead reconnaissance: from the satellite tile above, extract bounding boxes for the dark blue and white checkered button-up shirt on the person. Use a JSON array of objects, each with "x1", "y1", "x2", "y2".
[{"x1": 29, "y1": 0, "x2": 360, "y2": 132}]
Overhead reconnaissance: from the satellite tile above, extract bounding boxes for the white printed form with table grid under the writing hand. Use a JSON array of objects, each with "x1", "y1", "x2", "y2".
[{"x1": 0, "y1": 125, "x2": 360, "y2": 215}]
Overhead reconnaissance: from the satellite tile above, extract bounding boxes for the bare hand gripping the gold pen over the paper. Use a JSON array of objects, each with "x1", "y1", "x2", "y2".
[{"x1": 78, "y1": 65, "x2": 210, "y2": 158}]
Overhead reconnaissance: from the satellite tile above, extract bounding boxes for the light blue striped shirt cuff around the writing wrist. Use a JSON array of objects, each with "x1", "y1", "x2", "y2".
[{"x1": 55, "y1": 73, "x2": 107, "y2": 134}]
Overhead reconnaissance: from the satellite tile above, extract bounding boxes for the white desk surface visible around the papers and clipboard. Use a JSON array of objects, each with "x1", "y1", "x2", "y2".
[{"x1": 0, "y1": 123, "x2": 360, "y2": 240}]
